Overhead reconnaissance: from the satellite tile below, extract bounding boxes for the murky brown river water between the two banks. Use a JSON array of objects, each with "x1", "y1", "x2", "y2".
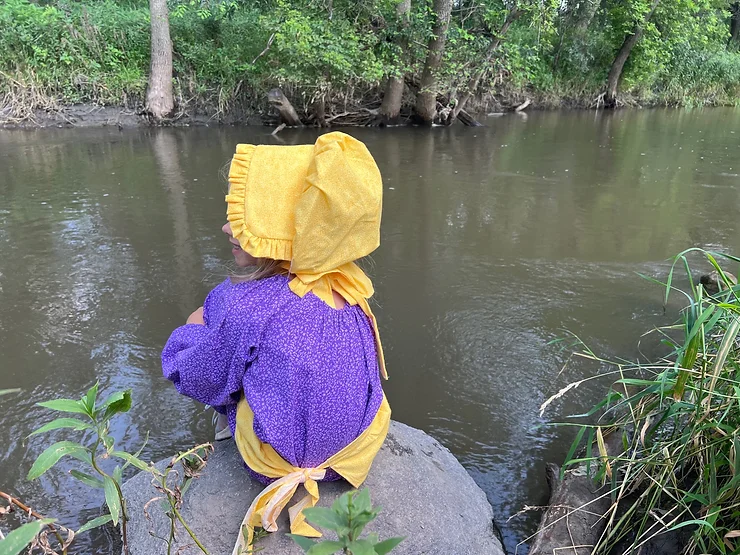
[{"x1": 0, "y1": 109, "x2": 740, "y2": 553}]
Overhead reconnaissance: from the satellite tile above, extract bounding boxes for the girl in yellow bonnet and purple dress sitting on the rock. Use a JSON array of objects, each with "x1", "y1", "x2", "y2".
[{"x1": 162, "y1": 132, "x2": 390, "y2": 553}]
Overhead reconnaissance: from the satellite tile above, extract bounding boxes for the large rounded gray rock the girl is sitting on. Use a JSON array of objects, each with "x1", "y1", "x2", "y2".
[{"x1": 123, "y1": 422, "x2": 504, "y2": 555}]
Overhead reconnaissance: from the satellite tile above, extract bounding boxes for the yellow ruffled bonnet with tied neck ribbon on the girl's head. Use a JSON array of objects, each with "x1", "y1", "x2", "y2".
[{"x1": 226, "y1": 132, "x2": 387, "y2": 378}]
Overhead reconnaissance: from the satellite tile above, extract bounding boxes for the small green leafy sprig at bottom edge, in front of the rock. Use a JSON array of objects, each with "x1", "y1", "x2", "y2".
[{"x1": 288, "y1": 488, "x2": 404, "y2": 555}]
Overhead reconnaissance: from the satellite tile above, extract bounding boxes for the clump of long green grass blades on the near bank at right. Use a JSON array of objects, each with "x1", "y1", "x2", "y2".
[{"x1": 551, "y1": 249, "x2": 740, "y2": 555}]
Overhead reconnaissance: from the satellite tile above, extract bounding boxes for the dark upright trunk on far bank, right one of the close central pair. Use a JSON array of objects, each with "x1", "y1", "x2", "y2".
[{"x1": 416, "y1": 0, "x2": 452, "y2": 125}]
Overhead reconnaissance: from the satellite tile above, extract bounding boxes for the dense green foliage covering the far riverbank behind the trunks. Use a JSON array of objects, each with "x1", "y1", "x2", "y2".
[{"x1": 0, "y1": 0, "x2": 740, "y2": 116}]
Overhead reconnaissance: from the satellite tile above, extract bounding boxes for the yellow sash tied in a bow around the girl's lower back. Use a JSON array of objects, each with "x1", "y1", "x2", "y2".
[{"x1": 232, "y1": 395, "x2": 391, "y2": 555}]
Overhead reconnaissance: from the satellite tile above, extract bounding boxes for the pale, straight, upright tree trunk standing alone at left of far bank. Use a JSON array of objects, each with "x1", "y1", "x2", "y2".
[{"x1": 146, "y1": 0, "x2": 175, "y2": 120}]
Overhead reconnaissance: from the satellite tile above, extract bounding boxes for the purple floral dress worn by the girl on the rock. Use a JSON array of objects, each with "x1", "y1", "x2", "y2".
[{"x1": 162, "y1": 276, "x2": 383, "y2": 482}]
